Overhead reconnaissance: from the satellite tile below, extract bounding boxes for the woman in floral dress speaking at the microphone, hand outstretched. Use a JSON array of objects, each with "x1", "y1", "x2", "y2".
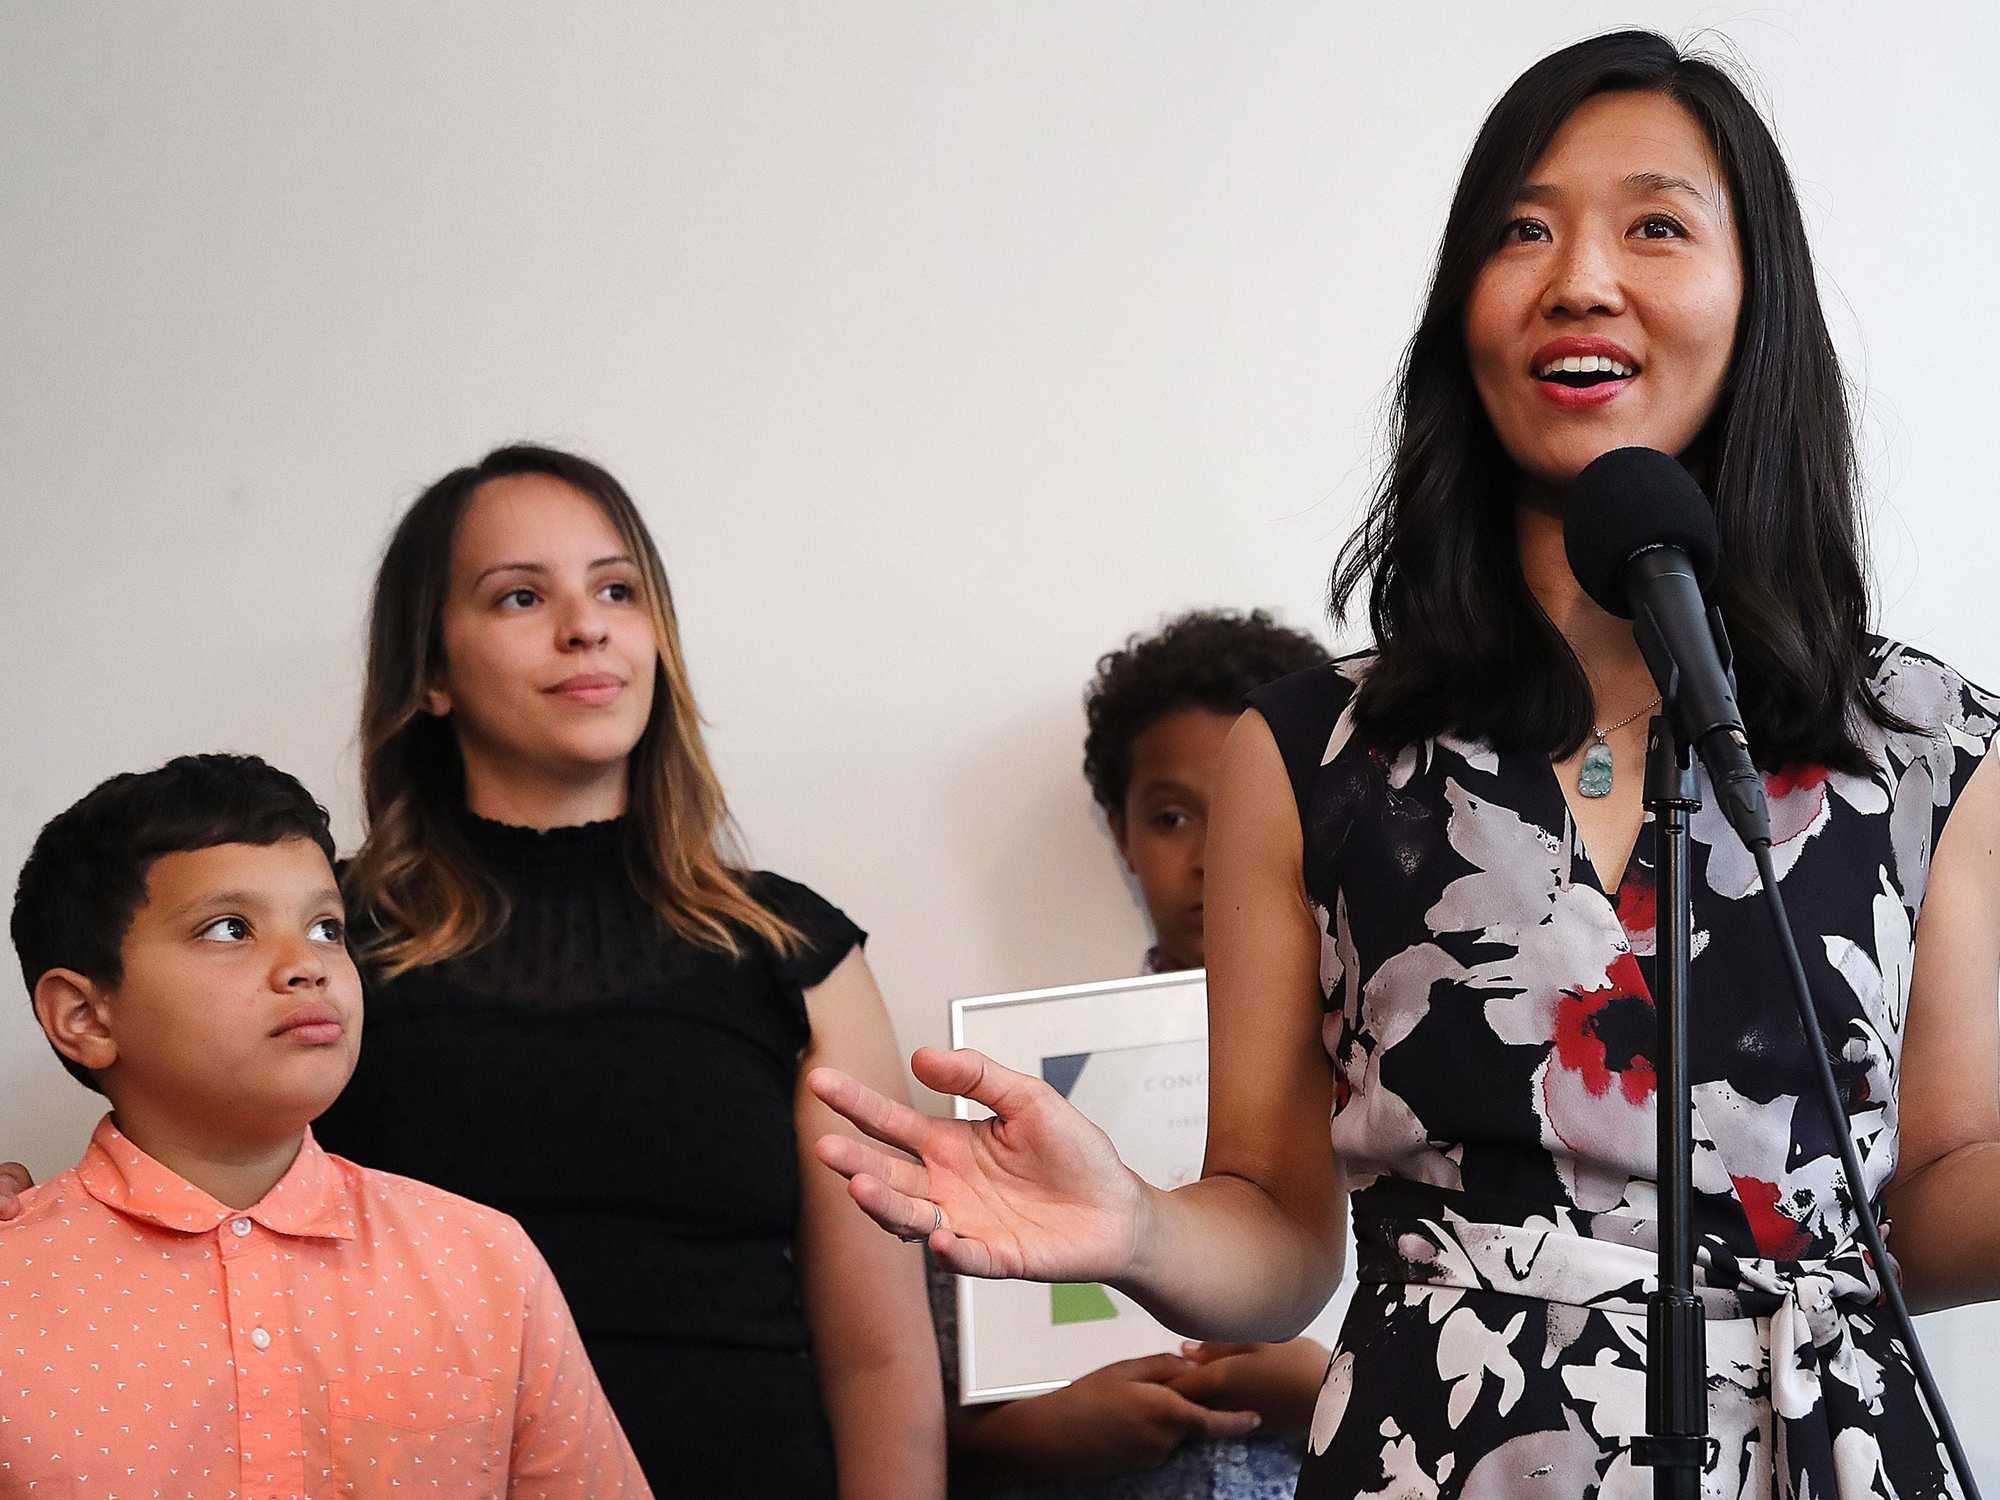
[{"x1": 808, "y1": 32, "x2": 2000, "y2": 1500}]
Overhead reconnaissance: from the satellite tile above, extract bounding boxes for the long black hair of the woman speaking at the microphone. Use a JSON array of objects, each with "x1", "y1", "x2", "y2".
[{"x1": 1330, "y1": 32, "x2": 1906, "y2": 772}]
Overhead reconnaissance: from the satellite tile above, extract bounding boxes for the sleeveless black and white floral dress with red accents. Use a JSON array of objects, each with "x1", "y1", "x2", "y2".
[{"x1": 1252, "y1": 642, "x2": 2000, "y2": 1500}]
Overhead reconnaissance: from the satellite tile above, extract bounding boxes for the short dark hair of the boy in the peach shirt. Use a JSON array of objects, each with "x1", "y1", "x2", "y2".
[{"x1": 12, "y1": 756, "x2": 334, "y2": 1094}]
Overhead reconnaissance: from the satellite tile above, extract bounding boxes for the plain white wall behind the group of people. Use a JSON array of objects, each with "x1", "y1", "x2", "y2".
[{"x1": 0, "y1": 0, "x2": 2000, "y2": 1486}]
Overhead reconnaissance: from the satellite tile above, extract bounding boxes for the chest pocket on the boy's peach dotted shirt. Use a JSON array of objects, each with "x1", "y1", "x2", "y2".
[{"x1": 326, "y1": 1370, "x2": 508, "y2": 1496}]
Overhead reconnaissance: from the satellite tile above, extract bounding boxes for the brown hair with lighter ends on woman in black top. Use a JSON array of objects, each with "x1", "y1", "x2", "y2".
[{"x1": 344, "y1": 444, "x2": 800, "y2": 978}]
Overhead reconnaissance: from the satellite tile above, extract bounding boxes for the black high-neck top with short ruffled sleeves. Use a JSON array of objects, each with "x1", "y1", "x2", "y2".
[{"x1": 314, "y1": 814, "x2": 864, "y2": 1496}]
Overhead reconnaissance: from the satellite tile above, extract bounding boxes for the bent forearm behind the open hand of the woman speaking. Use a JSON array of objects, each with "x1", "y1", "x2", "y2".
[{"x1": 1112, "y1": 1174, "x2": 1346, "y2": 1344}]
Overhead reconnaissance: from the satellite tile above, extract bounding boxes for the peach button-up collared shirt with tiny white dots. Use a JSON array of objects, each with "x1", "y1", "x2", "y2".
[{"x1": 0, "y1": 1116, "x2": 652, "y2": 1500}]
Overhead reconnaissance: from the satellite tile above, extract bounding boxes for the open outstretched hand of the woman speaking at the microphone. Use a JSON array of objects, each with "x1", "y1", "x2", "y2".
[{"x1": 806, "y1": 1048, "x2": 1146, "y2": 1282}]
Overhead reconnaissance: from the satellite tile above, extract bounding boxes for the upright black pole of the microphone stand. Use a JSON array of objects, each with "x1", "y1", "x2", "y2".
[{"x1": 1632, "y1": 716, "x2": 1710, "y2": 1500}]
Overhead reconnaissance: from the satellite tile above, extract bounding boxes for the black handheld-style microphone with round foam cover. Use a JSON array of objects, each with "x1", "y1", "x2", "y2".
[{"x1": 1562, "y1": 448, "x2": 1770, "y2": 850}]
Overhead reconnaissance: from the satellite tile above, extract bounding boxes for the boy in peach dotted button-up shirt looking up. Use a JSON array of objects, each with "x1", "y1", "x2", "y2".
[{"x1": 0, "y1": 756, "x2": 650, "y2": 1500}]
